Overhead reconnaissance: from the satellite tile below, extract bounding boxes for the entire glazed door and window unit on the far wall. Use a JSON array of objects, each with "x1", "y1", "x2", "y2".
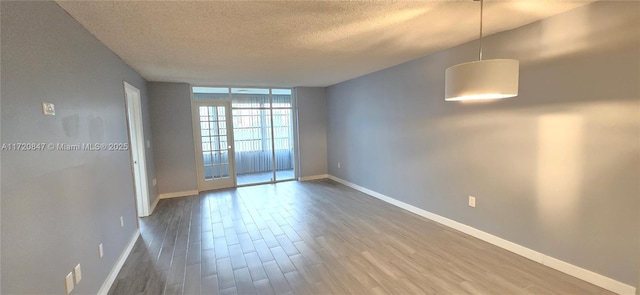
[{"x1": 192, "y1": 87, "x2": 296, "y2": 190}]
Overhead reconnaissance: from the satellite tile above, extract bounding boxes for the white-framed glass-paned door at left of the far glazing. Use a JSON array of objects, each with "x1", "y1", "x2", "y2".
[{"x1": 194, "y1": 101, "x2": 236, "y2": 191}]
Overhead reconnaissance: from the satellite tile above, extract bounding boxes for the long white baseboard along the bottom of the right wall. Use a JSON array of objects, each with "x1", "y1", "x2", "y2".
[{"x1": 329, "y1": 175, "x2": 636, "y2": 295}]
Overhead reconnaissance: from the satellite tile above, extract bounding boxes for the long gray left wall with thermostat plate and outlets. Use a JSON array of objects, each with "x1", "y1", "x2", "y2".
[{"x1": 0, "y1": 1, "x2": 155, "y2": 294}]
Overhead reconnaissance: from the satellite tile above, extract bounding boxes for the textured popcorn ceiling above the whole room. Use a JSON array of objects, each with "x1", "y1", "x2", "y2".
[{"x1": 57, "y1": 0, "x2": 592, "y2": 87}]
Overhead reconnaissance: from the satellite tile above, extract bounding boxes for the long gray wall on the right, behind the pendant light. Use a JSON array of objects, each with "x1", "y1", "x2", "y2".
[{"x1": 327, "y1": 2, "x2": 640, "y2": 286}]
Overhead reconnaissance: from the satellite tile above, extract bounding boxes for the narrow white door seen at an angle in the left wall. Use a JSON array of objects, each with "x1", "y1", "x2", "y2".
[{"x1": 124, "y1": 82, "x2": 149, "y2": 217}]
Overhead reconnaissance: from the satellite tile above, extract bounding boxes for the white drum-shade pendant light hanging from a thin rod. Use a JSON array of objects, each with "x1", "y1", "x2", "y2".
[{"x1": 445, "y1": 0, "x2": 520, "y2": 101}]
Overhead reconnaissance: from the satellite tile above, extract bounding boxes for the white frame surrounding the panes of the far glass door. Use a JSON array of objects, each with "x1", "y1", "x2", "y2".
[{"x1": 191, "y1": 99, "x2": 238, "y2": 192}]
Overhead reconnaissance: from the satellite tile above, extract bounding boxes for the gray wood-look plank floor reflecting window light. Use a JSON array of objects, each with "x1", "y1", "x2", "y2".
[{"x1": 109, "y1": 180, "x2": 611, "y2": 294}]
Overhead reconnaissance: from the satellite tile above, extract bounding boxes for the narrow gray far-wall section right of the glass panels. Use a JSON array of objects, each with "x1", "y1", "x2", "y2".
[{"x1": 294, "y1": 87, "x2": 328, "y2": 177}]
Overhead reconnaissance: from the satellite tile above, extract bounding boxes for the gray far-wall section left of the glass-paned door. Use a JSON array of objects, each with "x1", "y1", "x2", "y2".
[{"x1": 148, "y1": 82, "x2": 198, "y2": 194}]
